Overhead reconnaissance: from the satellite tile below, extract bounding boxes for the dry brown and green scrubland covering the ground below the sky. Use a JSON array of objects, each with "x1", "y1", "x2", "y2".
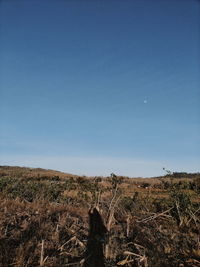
[{"x1": 0, "y1": 166, "x2": 200, "y2": 267}]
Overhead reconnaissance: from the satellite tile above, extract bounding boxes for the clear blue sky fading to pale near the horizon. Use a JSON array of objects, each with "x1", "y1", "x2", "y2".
[{"x1": 0, "y1": 0, "x2": 200, "y2": 177}]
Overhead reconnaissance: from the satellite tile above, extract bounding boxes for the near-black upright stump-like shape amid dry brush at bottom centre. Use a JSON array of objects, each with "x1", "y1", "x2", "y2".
[{"x1": 83, "y1": 208, "x2": 107, "y2": 267}]
